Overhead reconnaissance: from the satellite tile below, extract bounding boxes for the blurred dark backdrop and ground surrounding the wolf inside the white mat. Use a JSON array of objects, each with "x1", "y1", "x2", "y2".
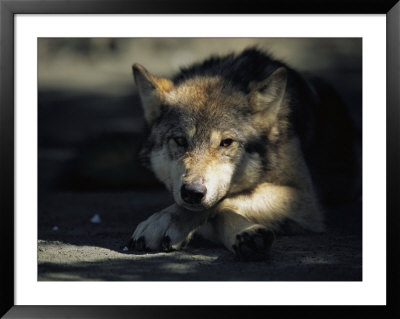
[{"x1": 38, "y1": 38, "x2": 362, "y2": 280}]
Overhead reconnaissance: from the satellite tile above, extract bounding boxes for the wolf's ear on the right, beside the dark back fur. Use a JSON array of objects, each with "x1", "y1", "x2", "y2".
[{"x1": 249, "y1": 67, "x2": 287, "y2": 117}]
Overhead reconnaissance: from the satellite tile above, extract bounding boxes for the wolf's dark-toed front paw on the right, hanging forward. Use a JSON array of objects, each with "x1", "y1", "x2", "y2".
[{"x1": 232, "y1": 225, "x2": 275, "y2": 261}]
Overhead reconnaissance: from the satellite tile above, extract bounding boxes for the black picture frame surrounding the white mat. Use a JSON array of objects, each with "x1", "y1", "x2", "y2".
[{"x1": 0, "y1": 0, "x2": 400, "y2": 318}]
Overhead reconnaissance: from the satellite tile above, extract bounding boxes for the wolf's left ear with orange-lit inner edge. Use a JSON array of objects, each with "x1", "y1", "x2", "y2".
[{"x1": 132, "y1": 64, "x2": 174, "y2": 125}]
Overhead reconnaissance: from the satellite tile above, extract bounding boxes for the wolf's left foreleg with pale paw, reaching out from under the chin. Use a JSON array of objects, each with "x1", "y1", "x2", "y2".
[{"x1": 129, "y1": 204, "x2": 209, "y2": 251}]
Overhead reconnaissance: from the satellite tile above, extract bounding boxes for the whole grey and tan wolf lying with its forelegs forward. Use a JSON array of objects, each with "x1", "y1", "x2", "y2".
[{"x1": 129, "y1": 48, "x2": 357, "y2": 260}]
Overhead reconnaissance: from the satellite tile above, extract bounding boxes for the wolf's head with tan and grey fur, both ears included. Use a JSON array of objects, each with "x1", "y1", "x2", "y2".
[{"x1": 133, "y1": 64, "x2": 287, "y2": 211}]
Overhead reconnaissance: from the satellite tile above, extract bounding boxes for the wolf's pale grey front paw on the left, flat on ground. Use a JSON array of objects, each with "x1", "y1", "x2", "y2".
[{"x1": 128, "y1": 210, "x2": 188, "y2": 251}]
